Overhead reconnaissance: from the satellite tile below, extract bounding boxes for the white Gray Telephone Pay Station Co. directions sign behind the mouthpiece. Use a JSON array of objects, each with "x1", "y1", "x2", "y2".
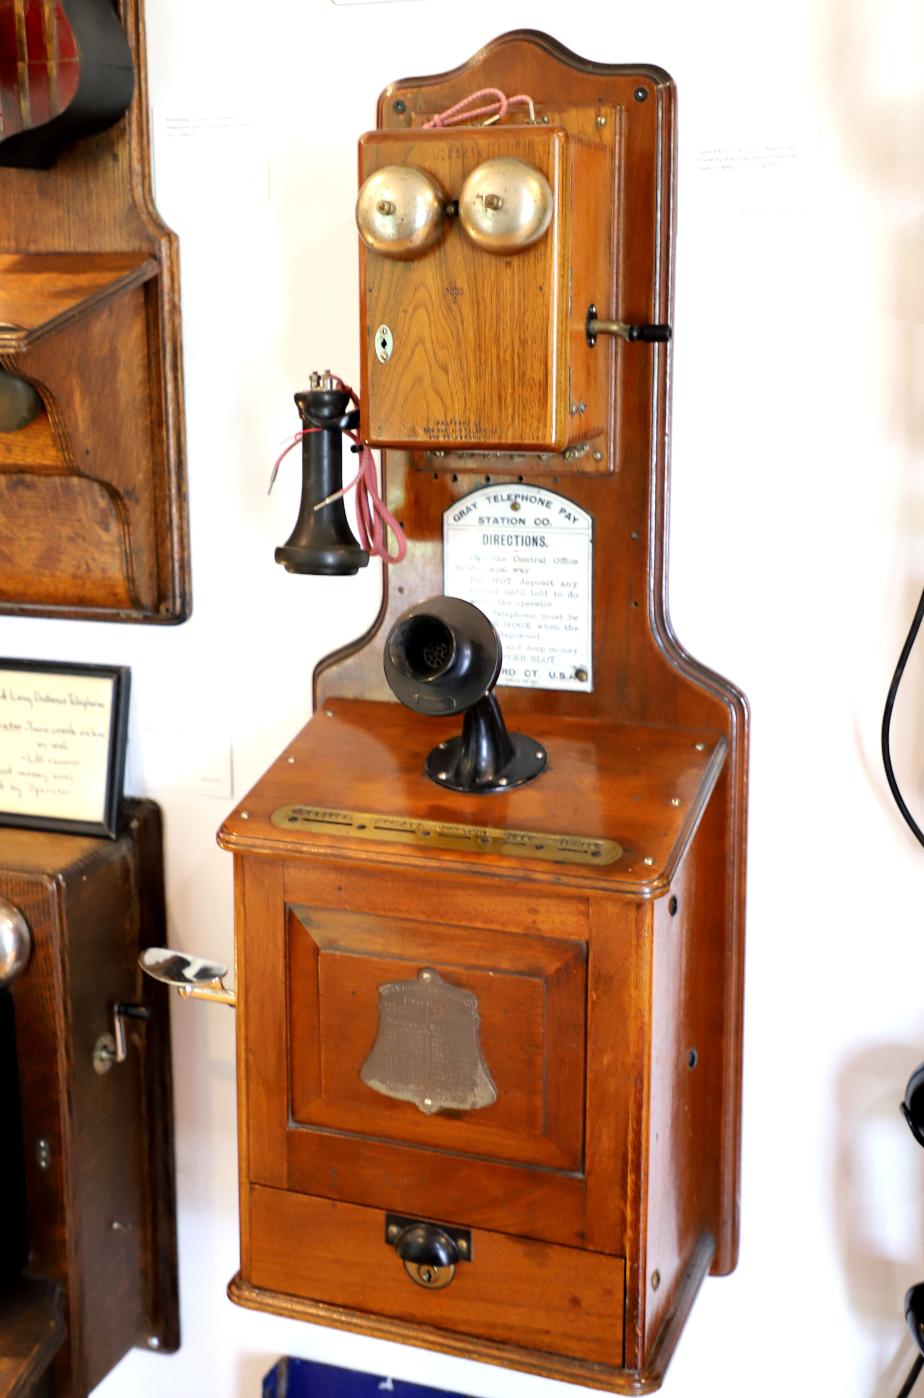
[{"x1": 443, "y1": 485, "x2": 594, "y2": 692}]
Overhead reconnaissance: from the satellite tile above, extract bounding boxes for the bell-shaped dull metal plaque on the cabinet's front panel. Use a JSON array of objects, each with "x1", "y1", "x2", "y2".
[{"x1": 359, "y1": 966, "x2": 498, "y2": 1116}]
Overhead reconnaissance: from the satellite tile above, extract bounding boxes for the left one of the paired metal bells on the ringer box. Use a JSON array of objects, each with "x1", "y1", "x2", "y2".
[{"x1": 356, "y1": 165, "x2": 446, "y2": 259}]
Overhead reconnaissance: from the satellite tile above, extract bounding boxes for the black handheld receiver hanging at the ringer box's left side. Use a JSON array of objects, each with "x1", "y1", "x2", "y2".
[{"x1": 275, "y1": 372, "x2": 369, "y2": 577}]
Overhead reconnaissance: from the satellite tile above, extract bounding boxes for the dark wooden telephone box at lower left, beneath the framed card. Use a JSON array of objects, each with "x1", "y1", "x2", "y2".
[{"x1": 0, "y1": 801, "x2": 179, "y2": 1398}]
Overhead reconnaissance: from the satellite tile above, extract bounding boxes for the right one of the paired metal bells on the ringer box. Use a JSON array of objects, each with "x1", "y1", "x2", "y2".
[{"x1": 459, "y1": 155, "x2": 554, "y2": 253}]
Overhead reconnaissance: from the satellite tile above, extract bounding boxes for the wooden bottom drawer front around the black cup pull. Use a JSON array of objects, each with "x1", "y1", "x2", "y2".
[{"x1": 242, "y1": 1187, "x2": 625, "y2": 1367}]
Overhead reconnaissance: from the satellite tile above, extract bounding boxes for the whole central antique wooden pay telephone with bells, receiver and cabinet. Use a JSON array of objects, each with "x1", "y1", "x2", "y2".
[{"x1": 143, "y1": 32, "x2": 746, "y2": 1392}]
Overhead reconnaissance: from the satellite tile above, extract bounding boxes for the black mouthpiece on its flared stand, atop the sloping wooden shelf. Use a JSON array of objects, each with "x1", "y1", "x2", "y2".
[{"x1": 384, "y1": 597, "x2": 548, "y2": 793}]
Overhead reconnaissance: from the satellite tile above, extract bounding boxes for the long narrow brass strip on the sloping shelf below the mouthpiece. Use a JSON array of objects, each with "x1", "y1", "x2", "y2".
[{"x1": 270, "y1": 805, "x2": 622, "y2": 864}]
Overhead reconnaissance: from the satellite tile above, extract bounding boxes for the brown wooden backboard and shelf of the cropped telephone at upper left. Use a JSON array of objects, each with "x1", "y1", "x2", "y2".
[{"x1": 0, "y1": 0, "x2": 192, "y2": 622}]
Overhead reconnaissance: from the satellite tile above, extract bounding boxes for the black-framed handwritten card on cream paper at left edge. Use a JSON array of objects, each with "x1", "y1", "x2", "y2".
[{"x1": 0, "y1": 658, "x2": 131, "y2": 839}]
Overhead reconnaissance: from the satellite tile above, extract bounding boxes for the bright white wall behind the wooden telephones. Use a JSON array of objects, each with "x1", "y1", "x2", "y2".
[{"x1": 8, "y1": 0, "x2": 924, "y2": 1398}]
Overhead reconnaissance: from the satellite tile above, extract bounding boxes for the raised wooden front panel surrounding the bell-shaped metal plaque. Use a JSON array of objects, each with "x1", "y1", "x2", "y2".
[{"x1": 288, "y1": 906, "x2": 586, "y2": 1173}]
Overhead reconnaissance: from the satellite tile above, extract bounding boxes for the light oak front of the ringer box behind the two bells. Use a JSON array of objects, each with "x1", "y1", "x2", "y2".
[{"x1": 359, "y1": 126, "x2": 576, "y2": 450}]
